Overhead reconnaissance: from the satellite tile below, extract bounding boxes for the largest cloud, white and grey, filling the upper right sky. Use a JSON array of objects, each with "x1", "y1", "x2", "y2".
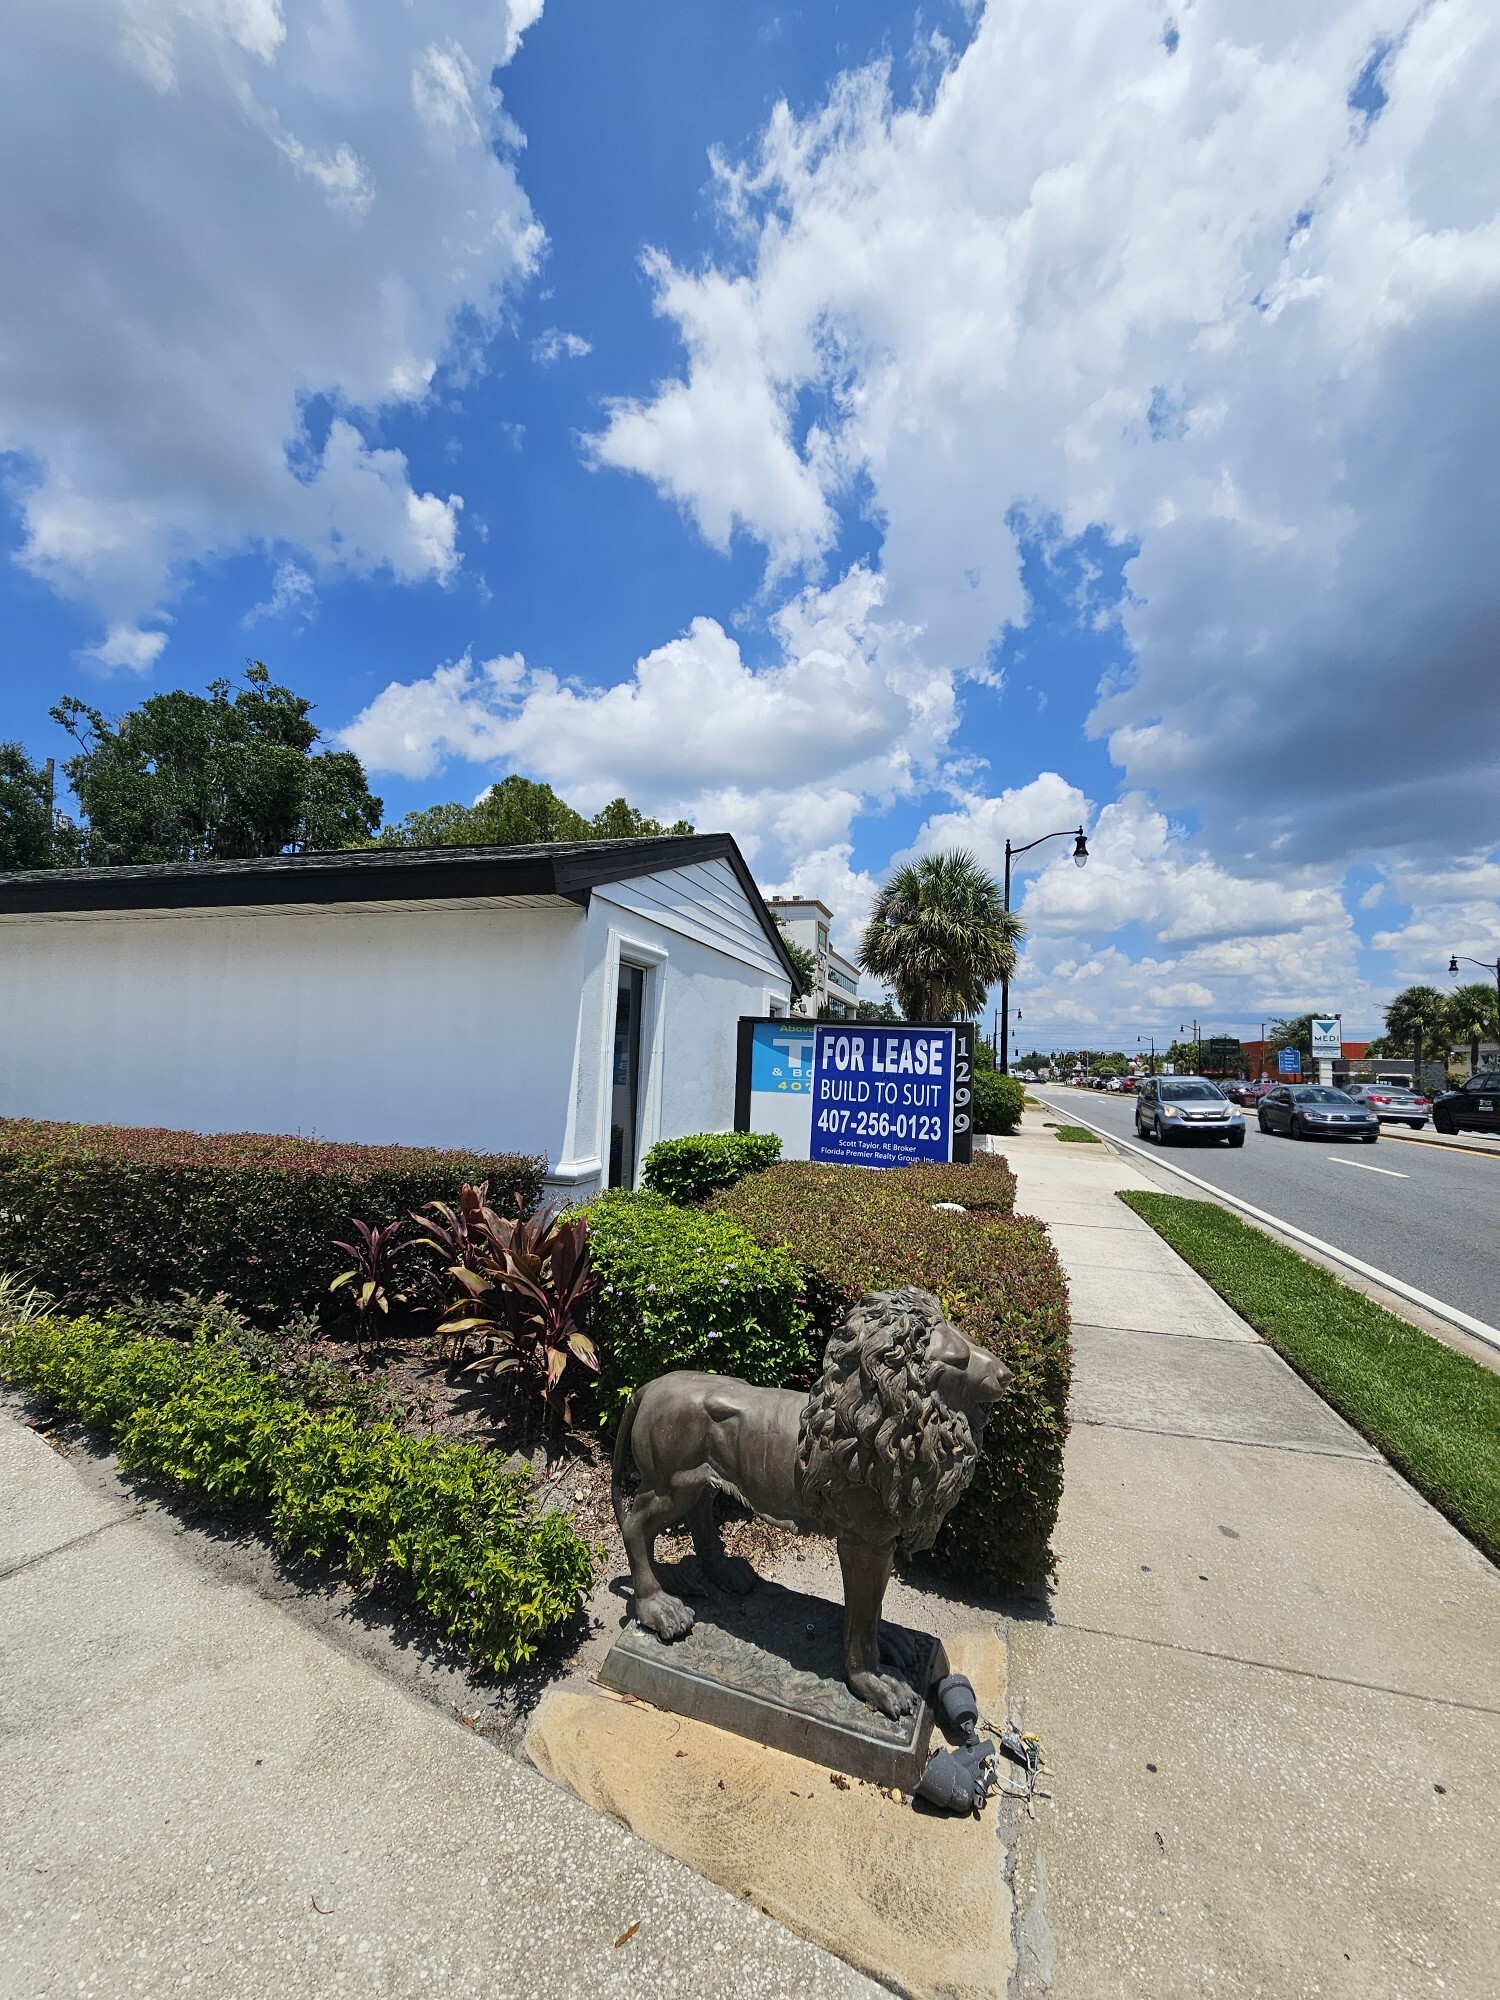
[{"x1": 592, "y1": 0, "x2": 1500, "y2": 868}]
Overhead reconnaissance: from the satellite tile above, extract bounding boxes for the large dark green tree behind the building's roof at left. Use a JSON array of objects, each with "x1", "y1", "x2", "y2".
[{"x1": 52, "y1": 660, "x2": 380, "y2": 868}]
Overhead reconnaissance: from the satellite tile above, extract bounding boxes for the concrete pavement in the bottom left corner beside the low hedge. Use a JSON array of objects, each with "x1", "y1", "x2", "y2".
[{"x1": 0, "y1": 1408, "x2": 876, "y2": 2000}]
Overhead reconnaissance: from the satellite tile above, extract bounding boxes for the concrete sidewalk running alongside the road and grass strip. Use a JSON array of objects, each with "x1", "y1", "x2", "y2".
[{"x1": 998, "y1": 1112, "x2": 1500, "y2": 2000}]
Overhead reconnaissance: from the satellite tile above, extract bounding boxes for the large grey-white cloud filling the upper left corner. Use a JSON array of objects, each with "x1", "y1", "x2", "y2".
[{"x1": 0, "y1": 0, "x2": 542, "y2": 668}]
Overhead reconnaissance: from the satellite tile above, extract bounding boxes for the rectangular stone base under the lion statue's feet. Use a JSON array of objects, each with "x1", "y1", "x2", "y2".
[{"x1": 598, "y1": 1582, "x2": 948, "y2": 1792}]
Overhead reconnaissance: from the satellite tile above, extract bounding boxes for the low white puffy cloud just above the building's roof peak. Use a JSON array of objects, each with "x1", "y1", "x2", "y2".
[{"x1": 342, "y1": 566, "x2": 958, "y2": 876}]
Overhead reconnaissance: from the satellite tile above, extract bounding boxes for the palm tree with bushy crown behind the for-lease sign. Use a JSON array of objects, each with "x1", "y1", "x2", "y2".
[{"x1": 860, "y1": 848, "x2": 1026, "y2": 1020}]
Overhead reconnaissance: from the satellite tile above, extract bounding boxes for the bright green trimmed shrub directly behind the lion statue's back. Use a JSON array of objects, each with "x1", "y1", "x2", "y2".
[{"x1": 588, "y1": 1176, "x2": 822, "y2": 1422}]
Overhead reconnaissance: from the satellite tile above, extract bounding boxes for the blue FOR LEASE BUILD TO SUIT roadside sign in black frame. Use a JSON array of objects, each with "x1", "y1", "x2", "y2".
[{"x1": 734, "y1": 1016, "x2": 974, "y2": 1166}]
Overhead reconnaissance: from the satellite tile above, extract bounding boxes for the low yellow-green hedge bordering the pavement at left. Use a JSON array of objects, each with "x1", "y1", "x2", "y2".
[{"x1": 0, "y1": 1318, "x2": 596, "y2": 1672}]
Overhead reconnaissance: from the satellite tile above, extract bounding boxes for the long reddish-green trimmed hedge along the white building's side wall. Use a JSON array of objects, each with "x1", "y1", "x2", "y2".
[{"x1": 0, "y1": 1118, "x2": 544, "y2": 1318}]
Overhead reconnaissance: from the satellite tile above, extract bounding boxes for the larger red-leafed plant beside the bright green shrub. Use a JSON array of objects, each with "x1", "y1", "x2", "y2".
[{"x1": 412, "y1": 1186, "x2": 598, "y2": 1424}]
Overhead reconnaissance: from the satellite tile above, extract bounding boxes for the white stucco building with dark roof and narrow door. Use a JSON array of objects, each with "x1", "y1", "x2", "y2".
[{"x1": 0, "y1": 834, "x2": 796, "y2": 1196}]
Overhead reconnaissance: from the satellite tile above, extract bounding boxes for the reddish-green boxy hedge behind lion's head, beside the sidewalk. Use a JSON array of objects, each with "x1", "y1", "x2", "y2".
[{"x1": 708, "y1": 1156, "x2": 1072, "y2": 1592}]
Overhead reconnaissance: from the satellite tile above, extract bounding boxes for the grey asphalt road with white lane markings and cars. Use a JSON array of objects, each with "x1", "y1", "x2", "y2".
[{"x1": 1032, "y1": 1084, "x2": 1500, "y2": 1326}]
